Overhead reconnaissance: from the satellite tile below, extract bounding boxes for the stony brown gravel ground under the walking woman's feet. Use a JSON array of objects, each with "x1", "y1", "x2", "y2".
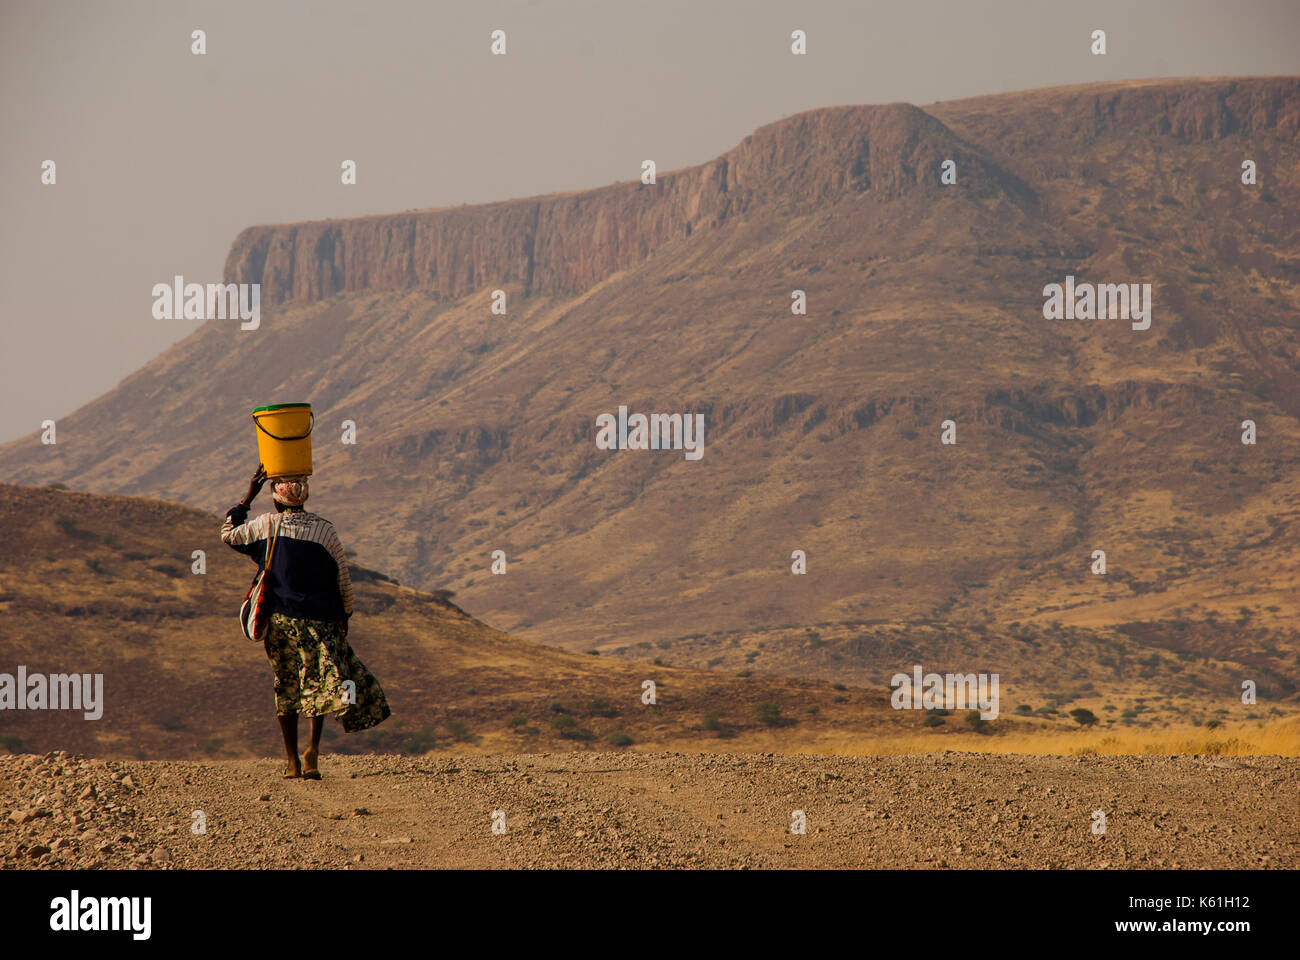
[{"x1": 0, "y1": 753, "x2": 1300, "y2": 869}]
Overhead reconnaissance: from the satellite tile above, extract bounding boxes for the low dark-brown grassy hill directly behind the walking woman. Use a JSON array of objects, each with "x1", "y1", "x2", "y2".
[{"x1": 0, "y1": 485, "x2": 918, "y2": 760}]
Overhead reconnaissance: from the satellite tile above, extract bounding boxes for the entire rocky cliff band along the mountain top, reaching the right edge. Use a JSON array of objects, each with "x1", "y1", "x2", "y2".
[{"x1": 225, "y1": 78, "x2": 1300, "y2": 306}]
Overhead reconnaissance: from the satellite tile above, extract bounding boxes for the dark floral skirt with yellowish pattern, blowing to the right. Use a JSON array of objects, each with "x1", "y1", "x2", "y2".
[{"x1": 265, "y1": 613, "x2": 393, "y2": 734}]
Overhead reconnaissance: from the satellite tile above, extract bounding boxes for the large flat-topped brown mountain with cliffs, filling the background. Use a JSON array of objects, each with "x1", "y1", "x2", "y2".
[{"x1": 0, "y1": 77, "x2": 1300, "y2": 709}]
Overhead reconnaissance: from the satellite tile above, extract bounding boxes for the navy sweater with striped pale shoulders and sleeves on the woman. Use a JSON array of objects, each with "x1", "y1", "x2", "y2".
[{"x1": 221, "y1": 505, "x2": 352, "y2": 622}]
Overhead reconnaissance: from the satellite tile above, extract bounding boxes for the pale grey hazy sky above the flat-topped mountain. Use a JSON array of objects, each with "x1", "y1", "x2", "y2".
[{"x1": 0, "y1": 0, "x2": 1300, "y2": 442}]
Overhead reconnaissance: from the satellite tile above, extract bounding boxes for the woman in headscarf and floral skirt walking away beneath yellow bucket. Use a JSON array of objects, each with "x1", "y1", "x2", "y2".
[{"x1": 221, "y1": 463, "x2": 391, "y2": 780}]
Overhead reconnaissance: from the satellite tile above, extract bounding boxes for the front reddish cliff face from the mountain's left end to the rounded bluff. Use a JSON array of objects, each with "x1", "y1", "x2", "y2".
[{"x1": 225, "y1": 104, "x2": 1031, "y2": 306}]
